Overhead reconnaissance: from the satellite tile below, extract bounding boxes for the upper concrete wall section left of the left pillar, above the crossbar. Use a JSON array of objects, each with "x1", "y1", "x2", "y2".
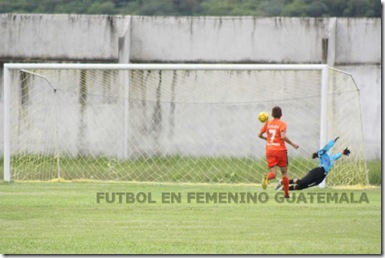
[{"x1": 0, "y1": 14, "x2": 129, "y2": 62}]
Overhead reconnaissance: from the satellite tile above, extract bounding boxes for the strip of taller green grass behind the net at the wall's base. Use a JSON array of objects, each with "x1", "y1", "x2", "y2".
[{"x1": 0, "y1": 155, "x2": 381, "y2": 185}]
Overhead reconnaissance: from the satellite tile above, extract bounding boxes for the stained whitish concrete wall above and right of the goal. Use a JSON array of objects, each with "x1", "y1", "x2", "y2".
[{"x1": 0, "y1": 14, "x2": 381, "y2": 158}]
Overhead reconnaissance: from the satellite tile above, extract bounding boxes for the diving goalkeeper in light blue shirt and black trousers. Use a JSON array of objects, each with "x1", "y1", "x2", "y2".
[{"x1": 274, "y1": 137, "x2": 350, "y2": 190}]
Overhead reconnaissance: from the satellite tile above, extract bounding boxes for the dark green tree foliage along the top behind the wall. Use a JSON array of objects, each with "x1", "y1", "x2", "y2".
[{"x1": 0, "y1": 0, "x2": 381, "y2": 17}]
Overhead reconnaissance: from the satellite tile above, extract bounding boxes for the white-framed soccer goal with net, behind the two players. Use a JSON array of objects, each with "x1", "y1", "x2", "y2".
[{"x1": 4, "y1": 63, "x2": 368, "y2": 185}]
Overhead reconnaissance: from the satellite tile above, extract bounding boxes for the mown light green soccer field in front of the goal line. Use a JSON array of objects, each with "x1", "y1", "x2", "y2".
[{"x1": 0, "y1": 182, "x2": 382, "y2": 254}]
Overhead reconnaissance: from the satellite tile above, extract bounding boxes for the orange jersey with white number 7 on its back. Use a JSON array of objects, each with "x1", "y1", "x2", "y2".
[{"x1": 261, "y1": 118, "x2": 287, "y2": 150}]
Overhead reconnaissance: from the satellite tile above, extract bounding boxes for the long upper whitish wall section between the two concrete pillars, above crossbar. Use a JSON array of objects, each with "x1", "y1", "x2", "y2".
[{"x1": 131, "y1": 17, "x2": 327, "y2": 63}]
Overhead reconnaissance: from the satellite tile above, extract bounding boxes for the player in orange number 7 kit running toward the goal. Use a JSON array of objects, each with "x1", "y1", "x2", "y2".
[{"x1": 258, "y1": 106, "x2": 299, "y2": 198}]
